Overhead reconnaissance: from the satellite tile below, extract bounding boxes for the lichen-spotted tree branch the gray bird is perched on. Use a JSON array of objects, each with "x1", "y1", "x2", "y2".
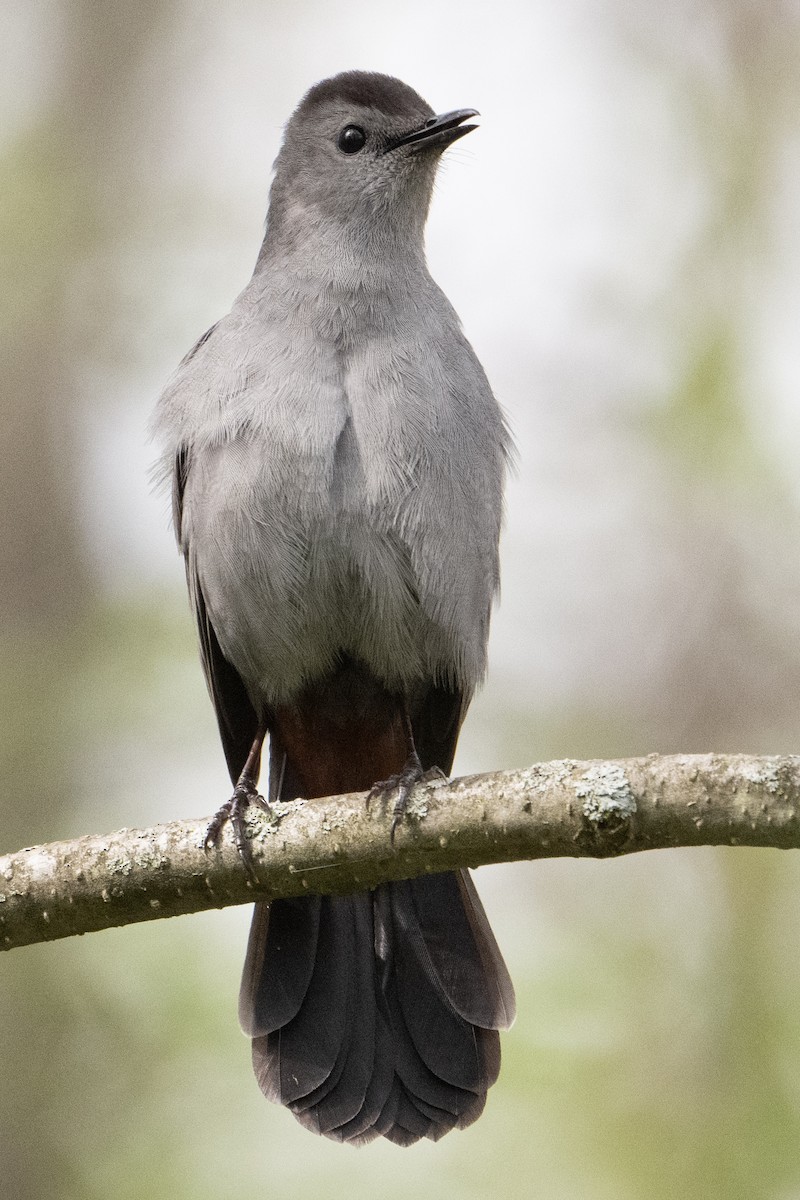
[{"x1": 0, "y1": 755, "x2": 800, "y2": 949}]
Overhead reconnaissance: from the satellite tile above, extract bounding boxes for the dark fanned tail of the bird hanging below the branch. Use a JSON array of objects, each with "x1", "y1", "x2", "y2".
[{"x1": 240, "y1": 871, "x2": 515, "y2": 1146}]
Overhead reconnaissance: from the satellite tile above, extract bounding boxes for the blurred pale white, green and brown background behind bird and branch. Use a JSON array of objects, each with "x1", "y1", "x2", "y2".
[{"x1": 0, "y1": 0, "x2": 800, "y2": 1200}]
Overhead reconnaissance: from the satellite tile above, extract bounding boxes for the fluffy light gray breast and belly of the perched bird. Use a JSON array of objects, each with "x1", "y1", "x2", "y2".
[{"x1": 164, "y1": 278, "x2": 504, "y2": 707}]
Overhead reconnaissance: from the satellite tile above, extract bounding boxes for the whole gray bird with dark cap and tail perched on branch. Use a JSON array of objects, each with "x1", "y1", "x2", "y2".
[{"x1": 156, "y1": 71, "x2": 515, "y2": 1145}]
